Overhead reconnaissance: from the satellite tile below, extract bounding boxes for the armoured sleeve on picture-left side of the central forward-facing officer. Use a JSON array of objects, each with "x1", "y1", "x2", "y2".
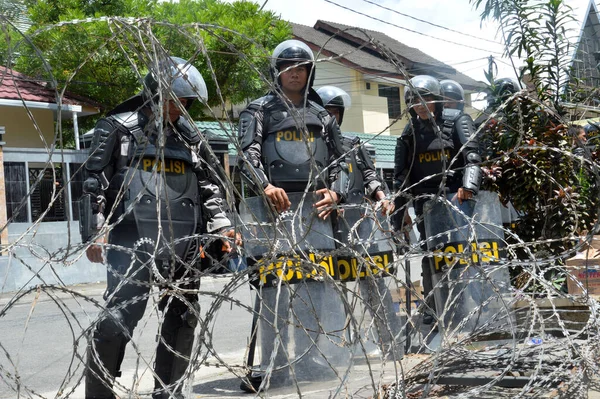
[{"x1": 238, "y1": 104, "x2": 269, "y2": 193}]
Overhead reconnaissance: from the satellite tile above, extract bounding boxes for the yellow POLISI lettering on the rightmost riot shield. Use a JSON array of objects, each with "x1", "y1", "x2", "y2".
[{"x1": 433, "y1": 240, "x2": 501, "y2": 272}]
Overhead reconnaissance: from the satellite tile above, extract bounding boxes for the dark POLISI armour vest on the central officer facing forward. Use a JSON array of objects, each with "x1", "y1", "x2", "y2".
[{"x1": 262, "y1": 106, "x2": 329, "y2": 191}]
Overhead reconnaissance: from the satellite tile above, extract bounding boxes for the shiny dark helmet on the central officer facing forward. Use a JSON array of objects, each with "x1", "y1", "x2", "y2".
[{"x1": 271, "y1": 39, "x2": 315, "y2": 94}]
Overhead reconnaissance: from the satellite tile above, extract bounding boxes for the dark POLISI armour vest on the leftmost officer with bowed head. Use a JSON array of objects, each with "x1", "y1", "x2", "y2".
[{"x1": 107, "y1": 113, "x2": 201, "y2": 259}]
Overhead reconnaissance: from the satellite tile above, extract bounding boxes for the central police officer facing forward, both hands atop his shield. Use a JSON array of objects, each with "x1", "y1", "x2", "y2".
[{"x1": 239, "y1": 40, "x2": 343, "y2": 392}]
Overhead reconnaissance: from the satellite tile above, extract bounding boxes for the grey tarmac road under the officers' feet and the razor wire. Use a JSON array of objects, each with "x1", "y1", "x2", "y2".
[{"x1": 0, "y1": 278, "x2": 600, "y2": 399}]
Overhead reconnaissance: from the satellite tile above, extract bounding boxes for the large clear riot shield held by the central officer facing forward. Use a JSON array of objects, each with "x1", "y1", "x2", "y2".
[{"x1": 240, "y1": 193, "x2": 350, "y2": 385}]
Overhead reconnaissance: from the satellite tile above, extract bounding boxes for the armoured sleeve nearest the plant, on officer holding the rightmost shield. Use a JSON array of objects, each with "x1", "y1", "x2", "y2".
[{"x1": 454, "y1": 114, "x2": 482, "y2": 194}]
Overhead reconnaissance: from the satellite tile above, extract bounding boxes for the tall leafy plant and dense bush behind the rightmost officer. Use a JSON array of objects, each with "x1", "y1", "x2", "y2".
[{"x1": 471, "y1": 0, "x2": 599, "y2": 291}]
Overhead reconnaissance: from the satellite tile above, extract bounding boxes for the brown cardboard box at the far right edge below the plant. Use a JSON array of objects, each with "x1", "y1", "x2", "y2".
[{"x1": 565, "y1": 247, "x2": 600, "y2": 295}]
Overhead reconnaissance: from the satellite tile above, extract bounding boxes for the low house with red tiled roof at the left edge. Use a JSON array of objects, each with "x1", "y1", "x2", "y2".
[{"x1": 0, "y1": 67, "x2": 106, "y2": 292}]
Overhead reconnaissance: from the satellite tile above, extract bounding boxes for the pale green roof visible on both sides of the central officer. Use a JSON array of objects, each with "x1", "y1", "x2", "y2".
[{"x1": 196, "y1": 122, "x2": 398, "y2": 169}]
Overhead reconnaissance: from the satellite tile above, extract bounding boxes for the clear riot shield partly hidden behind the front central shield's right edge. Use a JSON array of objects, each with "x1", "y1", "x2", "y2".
[{"x1": 334, "y1": 203, "x2": 404, "y2": 360}]
